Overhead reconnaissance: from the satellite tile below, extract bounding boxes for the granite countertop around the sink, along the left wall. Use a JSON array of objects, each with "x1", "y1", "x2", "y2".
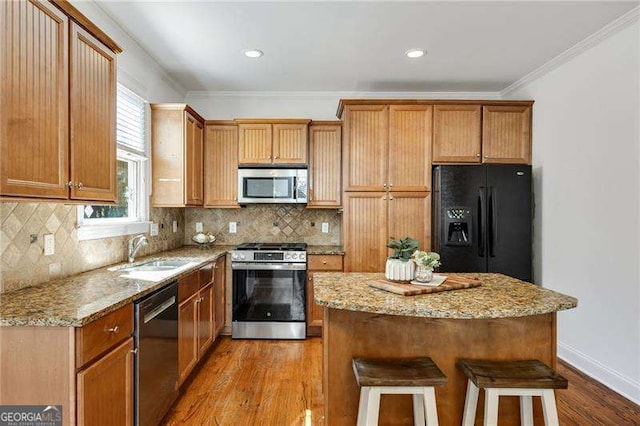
[{"x1": 0, "y1": 246, "x2": 233, "y2": 327}]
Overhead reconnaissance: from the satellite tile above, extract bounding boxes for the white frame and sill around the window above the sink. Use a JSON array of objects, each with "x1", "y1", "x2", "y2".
[{"x1": 77, "y1": 82, "x2": 151, "y2": 241}]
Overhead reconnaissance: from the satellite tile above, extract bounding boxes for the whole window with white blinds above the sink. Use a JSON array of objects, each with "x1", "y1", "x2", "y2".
[{"x1": 78, "y1": 84, "x2": 149, "y2": 240}]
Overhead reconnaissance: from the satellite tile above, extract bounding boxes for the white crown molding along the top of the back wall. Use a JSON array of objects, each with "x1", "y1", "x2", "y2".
[{"x1": 186, "y1": 91, "x2": 501, "y2": 99}]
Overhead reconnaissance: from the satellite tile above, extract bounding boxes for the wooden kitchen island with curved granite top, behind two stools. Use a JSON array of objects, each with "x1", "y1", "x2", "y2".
[{"x1": 314, "y1": 273, "x2": 577, "y2": 426}]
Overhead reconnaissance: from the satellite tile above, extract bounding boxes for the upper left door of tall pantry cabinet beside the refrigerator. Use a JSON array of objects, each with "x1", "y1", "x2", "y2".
[{"x1": 342, "y1": 105, "x2": 389, "y2": 191}]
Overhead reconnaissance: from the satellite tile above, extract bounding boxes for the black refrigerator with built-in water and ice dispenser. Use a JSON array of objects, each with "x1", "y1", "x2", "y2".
[{"x1": 432, "y1": 164, "x2": 532, "y2": 281}]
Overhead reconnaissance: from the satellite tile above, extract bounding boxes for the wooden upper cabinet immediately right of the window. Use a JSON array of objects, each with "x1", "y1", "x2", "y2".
[{"x1": 151, "y1": 104, "x2": 204, "y2": 207}]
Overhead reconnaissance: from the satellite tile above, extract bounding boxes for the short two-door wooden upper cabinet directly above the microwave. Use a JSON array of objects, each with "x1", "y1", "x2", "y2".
[{"x1": 235, "y1": 119, "x2": 310, "y2": 164}]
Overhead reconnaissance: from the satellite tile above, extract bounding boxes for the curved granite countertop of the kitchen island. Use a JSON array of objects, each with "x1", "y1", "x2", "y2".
[{"x1": 313, "y1": 272, "x2": 578, "y2": 319}]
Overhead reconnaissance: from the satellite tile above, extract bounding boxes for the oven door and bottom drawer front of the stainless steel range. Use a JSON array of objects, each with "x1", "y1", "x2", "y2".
[{"x1": 231, "y1": 263, "x2": 307, "y2": 339}]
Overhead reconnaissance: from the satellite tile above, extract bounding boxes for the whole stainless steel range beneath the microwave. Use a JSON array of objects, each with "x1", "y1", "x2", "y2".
[{"x1": 231, "y1": 243, "x2": 307, "y2": 339}]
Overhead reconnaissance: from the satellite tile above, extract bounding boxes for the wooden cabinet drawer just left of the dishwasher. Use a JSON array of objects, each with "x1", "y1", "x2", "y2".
[{"x1": 76, "y1": 304, "x2": 133, "y2": 368}]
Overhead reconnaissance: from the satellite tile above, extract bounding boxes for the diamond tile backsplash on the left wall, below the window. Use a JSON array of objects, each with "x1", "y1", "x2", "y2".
[{"x1": 0, "y1": 202, "x2": 184, "y2": 293}]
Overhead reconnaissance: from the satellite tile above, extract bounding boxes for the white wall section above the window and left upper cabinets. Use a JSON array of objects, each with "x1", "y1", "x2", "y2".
[{"x1": 71, "y1": 0, "x2": 186, "y2": 103}]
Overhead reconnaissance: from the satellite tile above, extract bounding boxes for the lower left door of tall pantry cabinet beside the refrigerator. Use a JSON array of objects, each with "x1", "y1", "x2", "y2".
[{"x1": 342, "y1": 192, "x2": 387, "y2": 272}]
